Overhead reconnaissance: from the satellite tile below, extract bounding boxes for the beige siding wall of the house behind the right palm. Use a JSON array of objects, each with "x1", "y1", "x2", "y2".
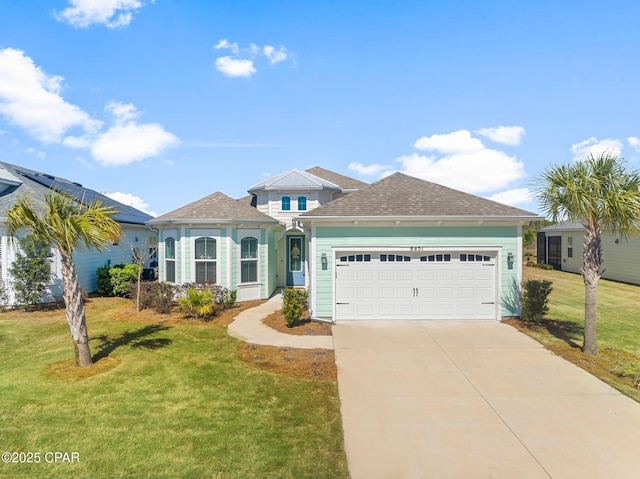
[{"x1": 562, "y1": 230, "x2": 640, "y2": 284}]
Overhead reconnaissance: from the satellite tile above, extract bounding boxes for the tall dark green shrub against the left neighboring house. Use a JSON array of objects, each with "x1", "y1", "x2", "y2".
[{"x1": 9, "y1": 234, "x2": 51, "y2": 310}]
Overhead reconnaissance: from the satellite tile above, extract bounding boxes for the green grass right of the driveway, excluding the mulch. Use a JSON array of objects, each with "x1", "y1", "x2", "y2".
[{"x1": 523, "y1": 267, "x2": 640, "y2": 358}]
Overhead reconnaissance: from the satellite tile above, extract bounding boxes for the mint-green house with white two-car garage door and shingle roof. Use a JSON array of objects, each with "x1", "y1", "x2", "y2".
[{"x1": 155, "y1": 167, "x2": 541, "y2": 321}]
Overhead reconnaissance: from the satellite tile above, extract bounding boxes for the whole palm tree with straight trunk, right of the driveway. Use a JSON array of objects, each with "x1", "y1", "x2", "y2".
[{"x1": 535, "y1": 152, "x2": 640, "y2": 355}]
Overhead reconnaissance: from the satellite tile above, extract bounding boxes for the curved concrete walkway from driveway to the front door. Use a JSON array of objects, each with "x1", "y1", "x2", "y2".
[{"x1": 227, "y1": 294, "x2": 333, "y2": 349}]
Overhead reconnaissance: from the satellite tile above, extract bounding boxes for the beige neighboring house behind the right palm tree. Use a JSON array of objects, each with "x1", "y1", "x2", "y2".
[{"x1": 537, "y1": 221, "x2": 640, "y2": 284}]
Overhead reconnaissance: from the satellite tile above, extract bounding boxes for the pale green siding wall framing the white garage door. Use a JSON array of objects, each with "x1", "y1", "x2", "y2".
[{"x1": 310, "y1": 225, "x2": 522, "y2": 318}]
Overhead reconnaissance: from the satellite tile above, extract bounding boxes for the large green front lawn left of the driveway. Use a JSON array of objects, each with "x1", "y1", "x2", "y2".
[{"x1": 0, "y1": 298, "x2": 348, "y2": 478}]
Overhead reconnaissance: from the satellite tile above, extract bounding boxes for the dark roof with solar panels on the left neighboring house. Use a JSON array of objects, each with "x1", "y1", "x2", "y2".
[{"x1": 0, "y1": 161, "x2": 153, "y2": 225}]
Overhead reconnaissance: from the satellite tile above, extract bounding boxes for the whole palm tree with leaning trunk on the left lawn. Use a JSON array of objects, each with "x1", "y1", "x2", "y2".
[{"x1": 7, "y1": 190, "x2": 121, "y2": 366}]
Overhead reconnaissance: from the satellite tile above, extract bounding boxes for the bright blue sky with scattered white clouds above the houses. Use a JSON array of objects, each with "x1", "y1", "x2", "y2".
[{"x1": 0, "y1": 0, "x2": 640, "y2": 218}]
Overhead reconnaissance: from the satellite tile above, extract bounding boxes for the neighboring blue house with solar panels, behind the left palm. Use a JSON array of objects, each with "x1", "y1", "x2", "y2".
[{"x1": 0, "y1": 162, "x2": 157, "y2": 305}]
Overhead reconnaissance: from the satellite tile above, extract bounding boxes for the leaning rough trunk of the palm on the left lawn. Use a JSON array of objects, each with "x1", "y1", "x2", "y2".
[{"x1": 62, "y1": 255, "x2": 93, "y2": 367}]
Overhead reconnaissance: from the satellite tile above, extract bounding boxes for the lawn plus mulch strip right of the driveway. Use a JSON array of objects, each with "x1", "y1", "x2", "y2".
[{"x1": 509, "y1": 266, "x2": 640, "y2": 401}]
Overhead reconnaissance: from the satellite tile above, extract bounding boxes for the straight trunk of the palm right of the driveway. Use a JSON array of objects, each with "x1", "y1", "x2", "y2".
[{"x1": 581, "y1": 228, "x2": 602, "y2": 356}]
